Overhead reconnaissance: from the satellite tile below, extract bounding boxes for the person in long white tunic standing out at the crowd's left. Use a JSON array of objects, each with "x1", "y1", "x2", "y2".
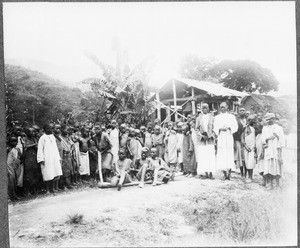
[{"x1": 37, "y1": 124, "x2": 62, "y2": 194}]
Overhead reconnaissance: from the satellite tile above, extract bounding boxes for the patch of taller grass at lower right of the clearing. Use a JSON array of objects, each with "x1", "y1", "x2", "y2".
[{"x1": 178, "y1": 190, "x2": 284, "y2": 244}]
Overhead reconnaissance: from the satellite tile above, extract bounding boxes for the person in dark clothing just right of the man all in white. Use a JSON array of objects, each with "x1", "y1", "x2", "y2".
[{"x1": 233, "y1": 108, "x2": 247, "y2": 178}]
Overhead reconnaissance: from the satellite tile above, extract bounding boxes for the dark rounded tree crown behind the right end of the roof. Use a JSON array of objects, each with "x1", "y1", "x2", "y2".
[{"x1": 210, "y1": 60, "x2": 279, "y2": 93}]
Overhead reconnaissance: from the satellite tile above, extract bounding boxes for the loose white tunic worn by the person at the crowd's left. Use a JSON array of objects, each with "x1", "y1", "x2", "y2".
[{"x1": 37, "y1": 134, "x2": 62, "y2": 181}]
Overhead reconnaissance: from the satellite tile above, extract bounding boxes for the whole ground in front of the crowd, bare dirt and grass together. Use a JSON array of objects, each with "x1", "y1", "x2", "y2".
[{"x1": 9, "y1": 165, "x2": 297, "y2": 247}]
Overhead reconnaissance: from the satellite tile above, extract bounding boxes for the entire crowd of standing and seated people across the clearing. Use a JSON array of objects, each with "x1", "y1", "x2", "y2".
[{"x1": 7, "y1": 102, "x2": 284, "y2": 200}]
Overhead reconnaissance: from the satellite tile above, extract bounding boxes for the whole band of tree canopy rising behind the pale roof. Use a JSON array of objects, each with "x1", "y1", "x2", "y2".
[{"x1": 179, "y1": 55, "x2": 279, "y2": 93}]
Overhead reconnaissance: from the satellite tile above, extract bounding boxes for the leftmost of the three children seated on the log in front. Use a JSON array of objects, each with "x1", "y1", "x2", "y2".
[{"x1": 111, "y1": 148, "x2": 132, "y2": 191}]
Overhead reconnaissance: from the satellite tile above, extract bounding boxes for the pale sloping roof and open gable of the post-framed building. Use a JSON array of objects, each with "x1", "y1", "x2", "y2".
[{"x1": 150, "y1": 78, "x2": 248, "y2": 101}]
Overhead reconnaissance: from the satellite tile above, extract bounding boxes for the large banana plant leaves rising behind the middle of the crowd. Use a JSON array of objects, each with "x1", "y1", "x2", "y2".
[{"x1": 83, "y1": 53, "x2": 154, "y2": 123}]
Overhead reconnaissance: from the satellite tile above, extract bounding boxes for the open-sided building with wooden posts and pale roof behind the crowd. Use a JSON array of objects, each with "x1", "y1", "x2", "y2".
[{"x1": 149, "y1": 78, "x2": 248, "y2": 120}]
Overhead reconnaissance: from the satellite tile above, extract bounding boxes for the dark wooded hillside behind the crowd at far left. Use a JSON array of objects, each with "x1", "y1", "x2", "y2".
[{"x1": 5, "y1": 64, "x2": 82, "y2": 128}]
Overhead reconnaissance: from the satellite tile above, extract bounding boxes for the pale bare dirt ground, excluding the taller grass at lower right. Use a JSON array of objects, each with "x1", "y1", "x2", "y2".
[{"x1": 9, "y1": 172, "x2": 297, "y2": 247}]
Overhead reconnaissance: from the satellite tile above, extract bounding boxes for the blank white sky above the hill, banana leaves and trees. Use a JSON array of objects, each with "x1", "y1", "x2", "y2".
[{"x1": 3, "y1": 1, "x2": 297, "y2": 94}]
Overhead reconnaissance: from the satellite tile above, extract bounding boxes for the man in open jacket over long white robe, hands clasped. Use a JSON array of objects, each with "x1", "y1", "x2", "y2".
[{"x1": 195, "y1": 103, "x2": 216, "y2": 179}]
